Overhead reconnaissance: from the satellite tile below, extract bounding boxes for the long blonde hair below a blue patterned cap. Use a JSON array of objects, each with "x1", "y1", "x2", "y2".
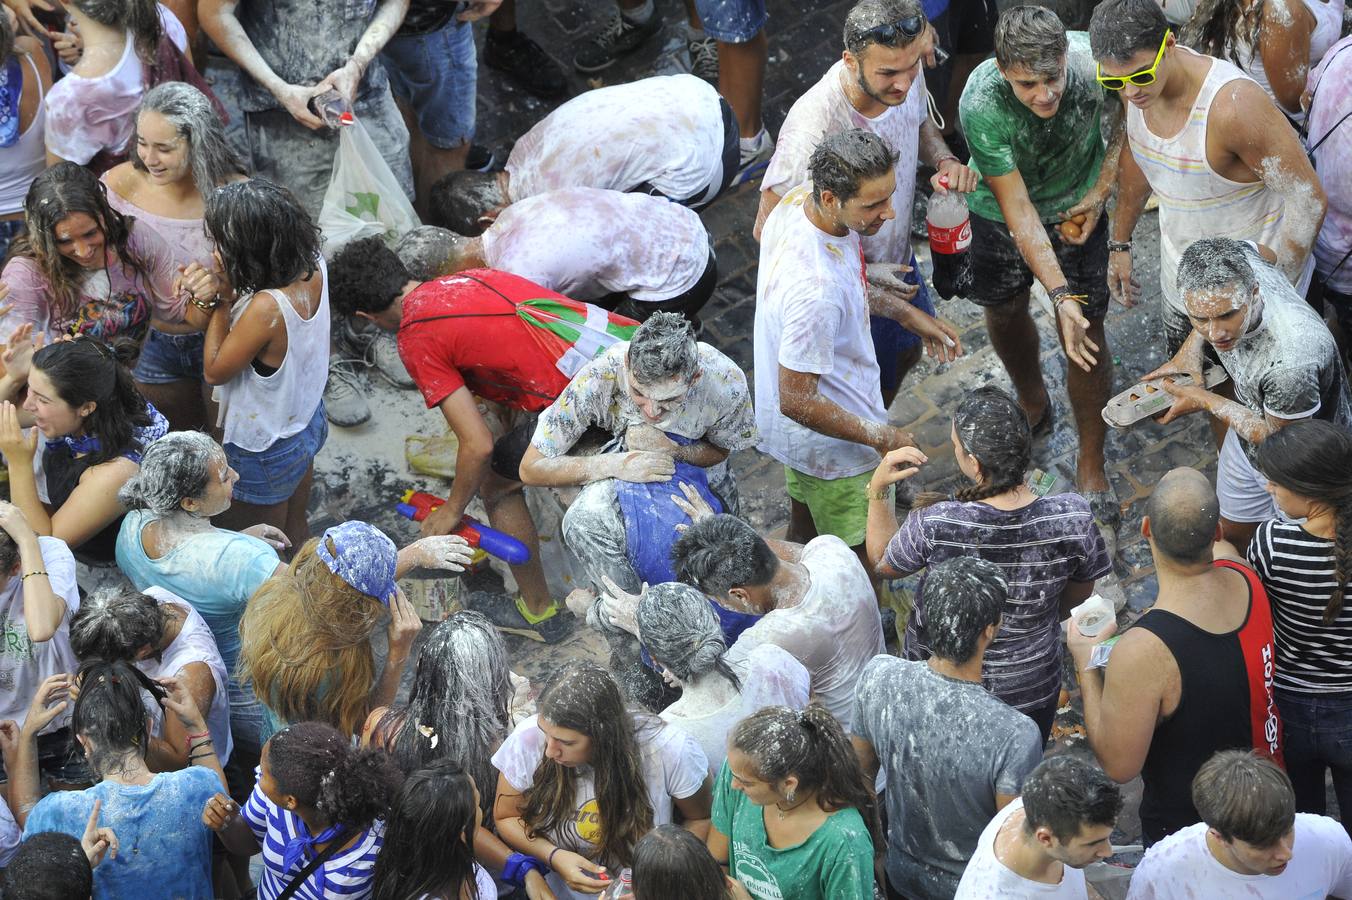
[{"x1": 239, "y1": 538, "x2": 385, "y2": 735}]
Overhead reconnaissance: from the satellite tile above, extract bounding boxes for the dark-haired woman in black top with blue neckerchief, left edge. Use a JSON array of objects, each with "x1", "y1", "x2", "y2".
[{"x1": 0, "y1": 336, "x2": 169, "y2": 564}]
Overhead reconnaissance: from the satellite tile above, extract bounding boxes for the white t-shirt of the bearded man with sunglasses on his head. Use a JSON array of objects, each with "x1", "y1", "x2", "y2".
[{"x1": 761, "y1": 61, "x2": 926, "y2": 264}]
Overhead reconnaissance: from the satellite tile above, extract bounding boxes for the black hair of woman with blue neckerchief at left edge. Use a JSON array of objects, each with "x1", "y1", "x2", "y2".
[{"x1": 32, "y1": 338, "x2": 150, "y2": 465}]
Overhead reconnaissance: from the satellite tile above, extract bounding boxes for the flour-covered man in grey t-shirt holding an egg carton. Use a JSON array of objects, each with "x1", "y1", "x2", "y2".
[{"x1": 1146, "y1": 238, "x2": 1352, "y2": 553}]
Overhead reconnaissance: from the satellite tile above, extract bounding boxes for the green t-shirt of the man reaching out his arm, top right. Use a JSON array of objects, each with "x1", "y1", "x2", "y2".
[{"x1": 957, "y1": 31, "x2": 1115, "y2": 222}]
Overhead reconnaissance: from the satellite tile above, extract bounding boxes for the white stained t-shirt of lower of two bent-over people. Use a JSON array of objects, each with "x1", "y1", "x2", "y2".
[{"x1": 484, "y1": 188, "x2": 708, "y2": 303}]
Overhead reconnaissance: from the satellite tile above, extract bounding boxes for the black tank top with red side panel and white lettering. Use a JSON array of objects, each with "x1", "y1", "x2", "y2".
[{"x1": 1136, "y1": 559, "x2": 1282, "y2": 843}]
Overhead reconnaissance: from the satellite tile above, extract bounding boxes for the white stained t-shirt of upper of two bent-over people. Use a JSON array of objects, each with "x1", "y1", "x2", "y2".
[{"x1": 507, "y1": 74, "x2": 723, "y2": 200}]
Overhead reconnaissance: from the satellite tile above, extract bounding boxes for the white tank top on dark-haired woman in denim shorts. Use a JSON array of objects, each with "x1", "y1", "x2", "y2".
[{"x1": 215, "y1": 259, "x2": 329, "y2": 453}]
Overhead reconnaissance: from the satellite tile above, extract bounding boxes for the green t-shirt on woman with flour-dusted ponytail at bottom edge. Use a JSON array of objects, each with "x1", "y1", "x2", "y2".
[{"x1": 713, "y1": 762, "x2": 873, "y2": 900}]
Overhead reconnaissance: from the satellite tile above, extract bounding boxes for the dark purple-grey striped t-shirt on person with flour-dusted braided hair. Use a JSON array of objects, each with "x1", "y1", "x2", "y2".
[{"x1": 884, "y1": 493, "x2": 1113, "y2": 712}]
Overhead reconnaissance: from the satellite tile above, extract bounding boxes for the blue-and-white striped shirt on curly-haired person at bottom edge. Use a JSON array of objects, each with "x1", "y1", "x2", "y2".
[{"x1": 241, "y1": 785, "x2": 385, "y2": 900}]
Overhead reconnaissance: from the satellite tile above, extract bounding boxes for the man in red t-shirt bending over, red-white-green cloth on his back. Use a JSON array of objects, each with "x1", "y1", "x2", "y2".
[{"x1": 330, "y1": 238, "x2": 643, "y2": 643}]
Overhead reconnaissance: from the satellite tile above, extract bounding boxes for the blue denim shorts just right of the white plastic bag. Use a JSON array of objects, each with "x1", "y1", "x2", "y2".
[{"x1": 380, "y1": 19, "x2": 479, "y2": 150}]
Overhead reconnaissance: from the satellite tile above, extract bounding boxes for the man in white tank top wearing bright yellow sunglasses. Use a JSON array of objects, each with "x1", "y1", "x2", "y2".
[{"x1": 1090, "y1": 0, "x2": 1328, "y2": 355}]
